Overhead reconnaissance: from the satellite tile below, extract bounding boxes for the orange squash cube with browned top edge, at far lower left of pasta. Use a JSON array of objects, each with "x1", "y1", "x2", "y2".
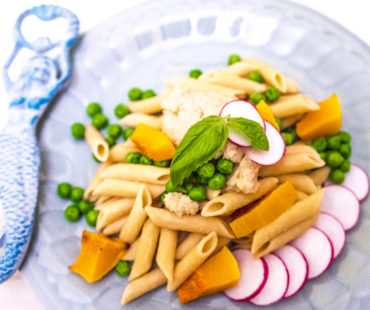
[{"x1": 69, "y1": 230, "x2": 127, "y2": 283}]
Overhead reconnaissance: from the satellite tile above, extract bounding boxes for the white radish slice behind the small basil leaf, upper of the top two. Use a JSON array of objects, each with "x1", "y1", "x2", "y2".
[{"x1": 220, "y1": 100, "x2": 266, "y2": 147}]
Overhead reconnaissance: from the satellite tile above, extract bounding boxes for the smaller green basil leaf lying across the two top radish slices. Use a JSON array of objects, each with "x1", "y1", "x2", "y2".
[{"x1": 227, "y1": 117, "x2": 269, "y2": 151}]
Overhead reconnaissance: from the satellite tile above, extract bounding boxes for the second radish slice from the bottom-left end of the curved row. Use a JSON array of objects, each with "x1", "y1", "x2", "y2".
[{"x1": 248, "y1": 253, "x2": 289, "y2": 306}]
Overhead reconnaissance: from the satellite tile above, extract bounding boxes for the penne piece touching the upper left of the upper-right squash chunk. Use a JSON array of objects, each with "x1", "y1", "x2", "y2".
[{"x1": 270, "y1": 94, "x2": 320, "y2": 118}]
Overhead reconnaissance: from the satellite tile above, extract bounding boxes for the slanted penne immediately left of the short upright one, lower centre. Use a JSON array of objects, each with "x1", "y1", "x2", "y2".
[{"x1": 128, "y1": 219, "x2": 159, "y2": 282}]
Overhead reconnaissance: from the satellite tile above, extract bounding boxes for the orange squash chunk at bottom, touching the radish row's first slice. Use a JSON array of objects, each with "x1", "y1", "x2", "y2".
[{"x1": 177, "y1": 246, "x2": 240, "y2": 304}]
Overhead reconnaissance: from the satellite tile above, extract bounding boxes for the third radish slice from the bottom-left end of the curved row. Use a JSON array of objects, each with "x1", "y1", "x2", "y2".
[{"x1": 274, "y1": 244, "x2": 308, "y2": 298}]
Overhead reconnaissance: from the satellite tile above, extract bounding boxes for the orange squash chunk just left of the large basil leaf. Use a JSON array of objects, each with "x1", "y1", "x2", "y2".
[{"x1": 131, "y1": 124, "x2": 176, "y2": 161}]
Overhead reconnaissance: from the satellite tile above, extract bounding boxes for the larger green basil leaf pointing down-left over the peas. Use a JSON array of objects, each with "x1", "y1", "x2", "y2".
[{"x1": 170, "y1": 115, "x2": 229, "y2": 186}]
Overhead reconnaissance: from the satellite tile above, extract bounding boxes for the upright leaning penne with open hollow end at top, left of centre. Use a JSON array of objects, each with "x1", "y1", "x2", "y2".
[{"x1": 119, "y1": 184, "x2": 152, "y2": 243}]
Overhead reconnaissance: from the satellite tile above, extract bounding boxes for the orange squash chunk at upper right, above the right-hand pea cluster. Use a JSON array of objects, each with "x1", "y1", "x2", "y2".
[{"x1": 296, "y1": 94, "x2": 342, "y2": 141}]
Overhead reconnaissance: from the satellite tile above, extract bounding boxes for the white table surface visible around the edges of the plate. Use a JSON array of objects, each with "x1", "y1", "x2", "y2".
[{"x1": 0, "y1": 0, "x2": 370, "y2": 310}]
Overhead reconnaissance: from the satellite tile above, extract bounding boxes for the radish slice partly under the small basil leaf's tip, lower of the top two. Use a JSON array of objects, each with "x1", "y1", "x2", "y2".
[{"x1": 246, "y1": 122, "x2": 285, "y2": 166}]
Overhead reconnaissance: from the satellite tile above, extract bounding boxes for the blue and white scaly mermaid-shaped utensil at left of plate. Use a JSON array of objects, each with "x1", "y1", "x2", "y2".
[{"x1": 0, "y1": 5, "x2": 79, "y2": 283}]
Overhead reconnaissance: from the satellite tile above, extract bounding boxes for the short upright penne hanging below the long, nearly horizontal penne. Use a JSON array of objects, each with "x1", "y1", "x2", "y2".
[{"x1": 156, "y1": 228, "x2": 178, "y2": 280}]
